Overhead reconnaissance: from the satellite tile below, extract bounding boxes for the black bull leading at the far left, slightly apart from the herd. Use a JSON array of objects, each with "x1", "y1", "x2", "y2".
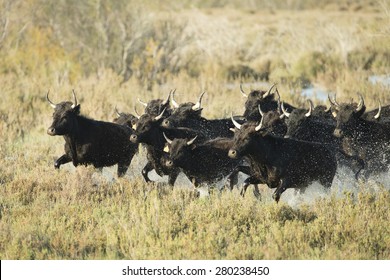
[{"x1": 46, "y1": 92, "x2": 137, "y2": 177}]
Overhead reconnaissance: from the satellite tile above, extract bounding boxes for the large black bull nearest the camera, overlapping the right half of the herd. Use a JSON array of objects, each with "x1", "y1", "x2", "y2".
[{"x1": 228, "y1": 119, "x2": 337, "y2": 201}]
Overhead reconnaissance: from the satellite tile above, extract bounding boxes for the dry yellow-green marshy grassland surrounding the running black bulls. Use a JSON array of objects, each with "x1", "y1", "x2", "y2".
[{"x1": 0, "y1": 0, "x2": 390, "y2": 259}]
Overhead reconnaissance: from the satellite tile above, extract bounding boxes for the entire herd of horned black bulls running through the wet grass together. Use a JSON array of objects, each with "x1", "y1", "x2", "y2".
[{"x1": 46, "y1": 85, "x2": 390, "y2": 202}]
